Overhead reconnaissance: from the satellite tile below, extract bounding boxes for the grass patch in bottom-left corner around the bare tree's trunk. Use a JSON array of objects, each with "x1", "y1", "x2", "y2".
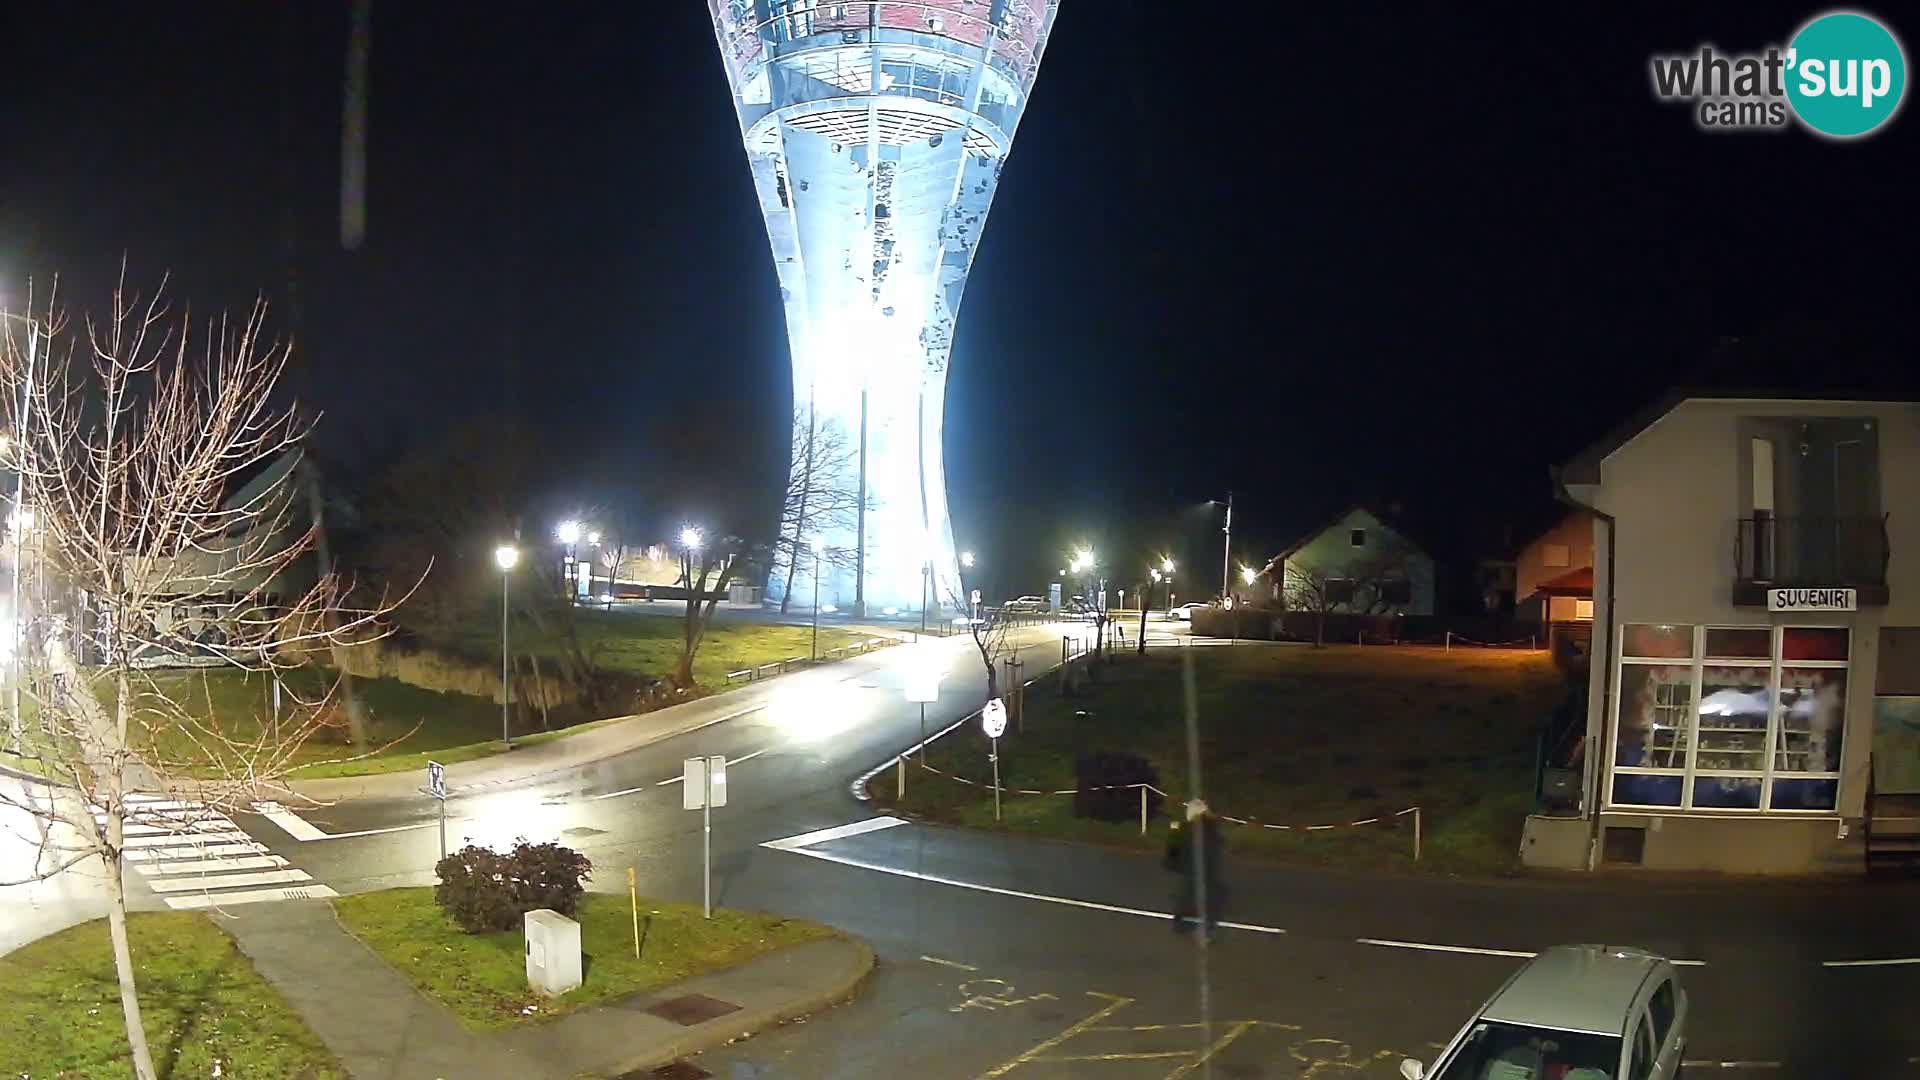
[{"x1": 0, "y1": 911, "x2": 348, "y2": 1080}]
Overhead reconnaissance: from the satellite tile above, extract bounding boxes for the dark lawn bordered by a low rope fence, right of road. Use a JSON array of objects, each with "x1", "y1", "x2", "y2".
[{"x1": 872, "y1": 644, "x2": 1565, "y2": 874}]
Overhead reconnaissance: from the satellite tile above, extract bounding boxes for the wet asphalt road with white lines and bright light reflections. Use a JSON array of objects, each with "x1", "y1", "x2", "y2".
[{"x1": 26, "y1": 628, "x2": 1920, "y2": 1080}]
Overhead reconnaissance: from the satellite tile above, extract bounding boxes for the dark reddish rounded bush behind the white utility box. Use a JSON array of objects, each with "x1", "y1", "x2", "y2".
[{"x1": 434, "y1": 838, "x2": 593, "y2": 934}]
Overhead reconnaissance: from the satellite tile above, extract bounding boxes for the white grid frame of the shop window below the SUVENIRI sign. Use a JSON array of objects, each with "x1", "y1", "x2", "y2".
[{"x1": 1605, "y1": 623, "x2": 1855, "y2": 817}]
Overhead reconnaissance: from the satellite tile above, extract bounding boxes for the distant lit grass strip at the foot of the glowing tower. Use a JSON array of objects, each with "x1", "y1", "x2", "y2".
[{"x1": 420, "y1": 600, "x2": 870, "y2": 688}]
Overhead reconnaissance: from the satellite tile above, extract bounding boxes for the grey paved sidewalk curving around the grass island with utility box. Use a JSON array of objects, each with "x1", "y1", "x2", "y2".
[{"x1": 215, "y1": 901, "x2": 874, "y2": 1080}]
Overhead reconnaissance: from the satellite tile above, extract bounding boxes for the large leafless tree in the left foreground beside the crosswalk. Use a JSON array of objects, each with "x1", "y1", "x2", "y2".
[{"x1": 0, "y1": 276, "x2": 397, "y2": 1080}]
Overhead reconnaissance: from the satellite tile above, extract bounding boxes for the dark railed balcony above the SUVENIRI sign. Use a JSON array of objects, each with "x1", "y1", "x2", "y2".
[{"x1": 1734, "y1": 517, "x2": 1889, "y2": 607}]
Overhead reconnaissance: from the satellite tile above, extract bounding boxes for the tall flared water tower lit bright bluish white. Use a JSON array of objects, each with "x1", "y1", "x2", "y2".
[{"x1": 708, "y1": 0, "x2": 1060, "y2": 613}]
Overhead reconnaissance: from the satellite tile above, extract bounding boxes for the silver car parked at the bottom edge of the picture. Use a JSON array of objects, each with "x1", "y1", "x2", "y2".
[{"x1": 1400, "y1": 945, "x2": 1686, "y2": 1080}]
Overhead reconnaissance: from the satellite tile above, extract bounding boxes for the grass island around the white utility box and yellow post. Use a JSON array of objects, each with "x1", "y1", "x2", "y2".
[{"x1": 334, "y1": 888, "x2": 833, "y2": 1028}]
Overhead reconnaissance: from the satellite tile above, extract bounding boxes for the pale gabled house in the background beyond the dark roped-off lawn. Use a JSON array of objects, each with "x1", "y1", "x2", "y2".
[{"x1": 1235, "y1": 505, "x2": 1434, "y2": 615}]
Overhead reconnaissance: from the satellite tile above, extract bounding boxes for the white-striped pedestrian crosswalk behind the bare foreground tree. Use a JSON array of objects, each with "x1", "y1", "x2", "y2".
[{"x1": 94, "y1": 796, "x2": 340, "y2": 911}]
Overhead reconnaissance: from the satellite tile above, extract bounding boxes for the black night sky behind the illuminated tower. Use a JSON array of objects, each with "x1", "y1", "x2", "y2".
[{"x1": 0, "y1": 0, "x2": 1920, "y2": 590}]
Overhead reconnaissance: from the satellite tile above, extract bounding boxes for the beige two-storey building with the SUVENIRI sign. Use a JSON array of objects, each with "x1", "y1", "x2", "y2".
[{"x1": 1523, "y1": 392, "x2": 1920, "y2": 872}]
